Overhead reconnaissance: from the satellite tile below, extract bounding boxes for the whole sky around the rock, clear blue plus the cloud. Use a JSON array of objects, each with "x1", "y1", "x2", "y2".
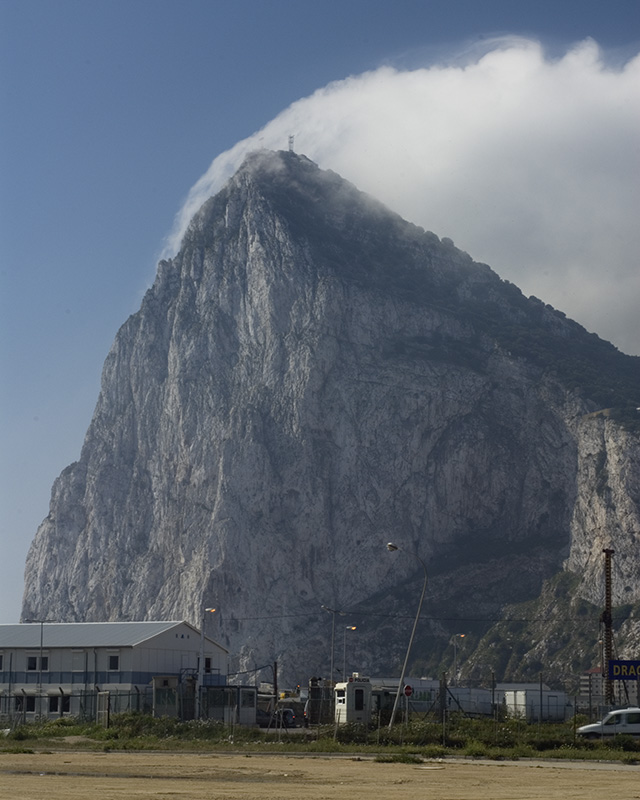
[{"x1": 0, "y1": 0, "x2": 640, "y2": 622}]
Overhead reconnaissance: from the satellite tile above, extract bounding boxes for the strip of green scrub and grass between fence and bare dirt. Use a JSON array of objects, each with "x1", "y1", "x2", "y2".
[{"x1": 0, "y1": 713, "x2": 640, "y2": 763}]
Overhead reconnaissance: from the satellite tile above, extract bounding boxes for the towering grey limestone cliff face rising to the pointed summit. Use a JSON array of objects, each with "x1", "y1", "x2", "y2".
[{"x1": 23, "y1": 153, "x2": 640, "y2": 681}]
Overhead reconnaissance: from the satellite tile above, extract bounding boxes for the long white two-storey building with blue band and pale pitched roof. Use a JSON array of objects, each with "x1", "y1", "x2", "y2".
[{"x1": 0, "y1": 621, "x2": 230, "y2": 722}]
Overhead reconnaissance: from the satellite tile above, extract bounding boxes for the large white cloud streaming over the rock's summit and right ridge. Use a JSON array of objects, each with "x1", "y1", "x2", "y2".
[{"x1": 169, "y1": 39, "x2": 640, "y2": 354}]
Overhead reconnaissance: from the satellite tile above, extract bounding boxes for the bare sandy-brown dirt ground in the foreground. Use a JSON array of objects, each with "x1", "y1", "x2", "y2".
[{"x1": 0, "y1": 753, "x2": 640, "y2": 800}]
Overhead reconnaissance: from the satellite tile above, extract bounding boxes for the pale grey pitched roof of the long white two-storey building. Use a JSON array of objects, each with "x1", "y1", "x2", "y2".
[{"x1": 0, "y1": 621, "x2": 199, "y2": 648}]
